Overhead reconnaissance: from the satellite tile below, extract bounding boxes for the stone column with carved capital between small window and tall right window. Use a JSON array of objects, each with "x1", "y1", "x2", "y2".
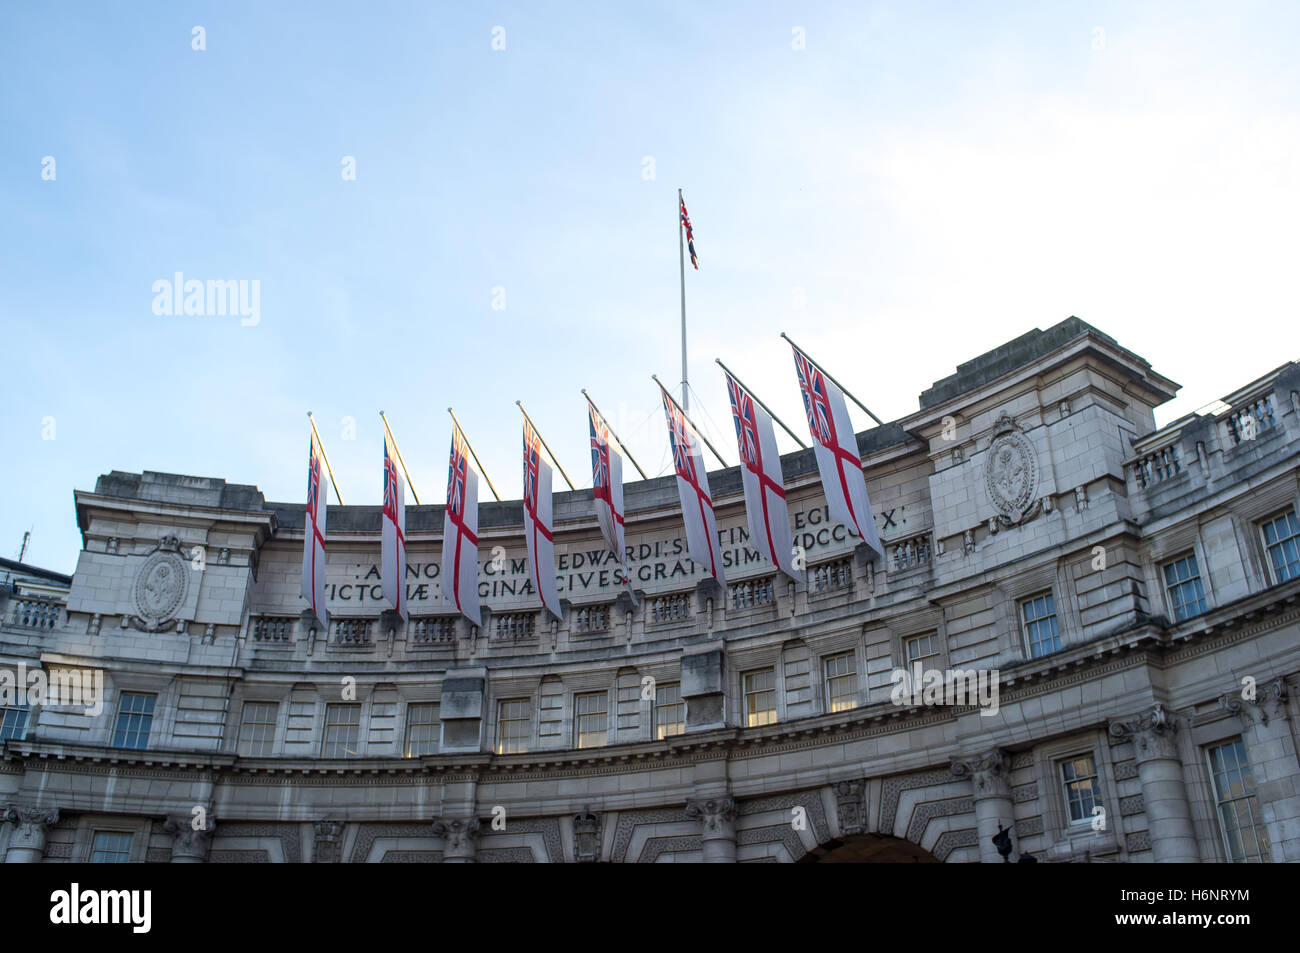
[{"x1": 1110, "y1": 705, "x2": 1201, "y2": 863}]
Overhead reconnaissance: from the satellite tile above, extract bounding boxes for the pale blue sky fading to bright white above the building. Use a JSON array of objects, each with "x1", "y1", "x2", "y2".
[{"x1": 0, "y1": 0, "x2": 1300, "y2": 571}]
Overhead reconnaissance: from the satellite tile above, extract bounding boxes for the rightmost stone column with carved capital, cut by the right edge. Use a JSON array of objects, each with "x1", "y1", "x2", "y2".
[{"x1": 1219, "y1": 679, "x2": 1300, "y2": 863}]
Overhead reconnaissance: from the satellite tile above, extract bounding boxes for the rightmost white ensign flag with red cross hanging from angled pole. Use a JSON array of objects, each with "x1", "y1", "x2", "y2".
[{"x1": 790, "y1": 343, "x2": 884, "y2": 555}]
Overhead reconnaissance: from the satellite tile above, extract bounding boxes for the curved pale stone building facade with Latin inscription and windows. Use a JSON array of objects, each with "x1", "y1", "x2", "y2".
[{"x1": 0, "y1": 319, "x2": 1300, "y2": 862}]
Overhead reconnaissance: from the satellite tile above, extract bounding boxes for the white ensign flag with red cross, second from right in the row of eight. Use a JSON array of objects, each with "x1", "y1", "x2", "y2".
[{"x1": 723, "y1": 369, "x2": 798, "y2": 579}]
